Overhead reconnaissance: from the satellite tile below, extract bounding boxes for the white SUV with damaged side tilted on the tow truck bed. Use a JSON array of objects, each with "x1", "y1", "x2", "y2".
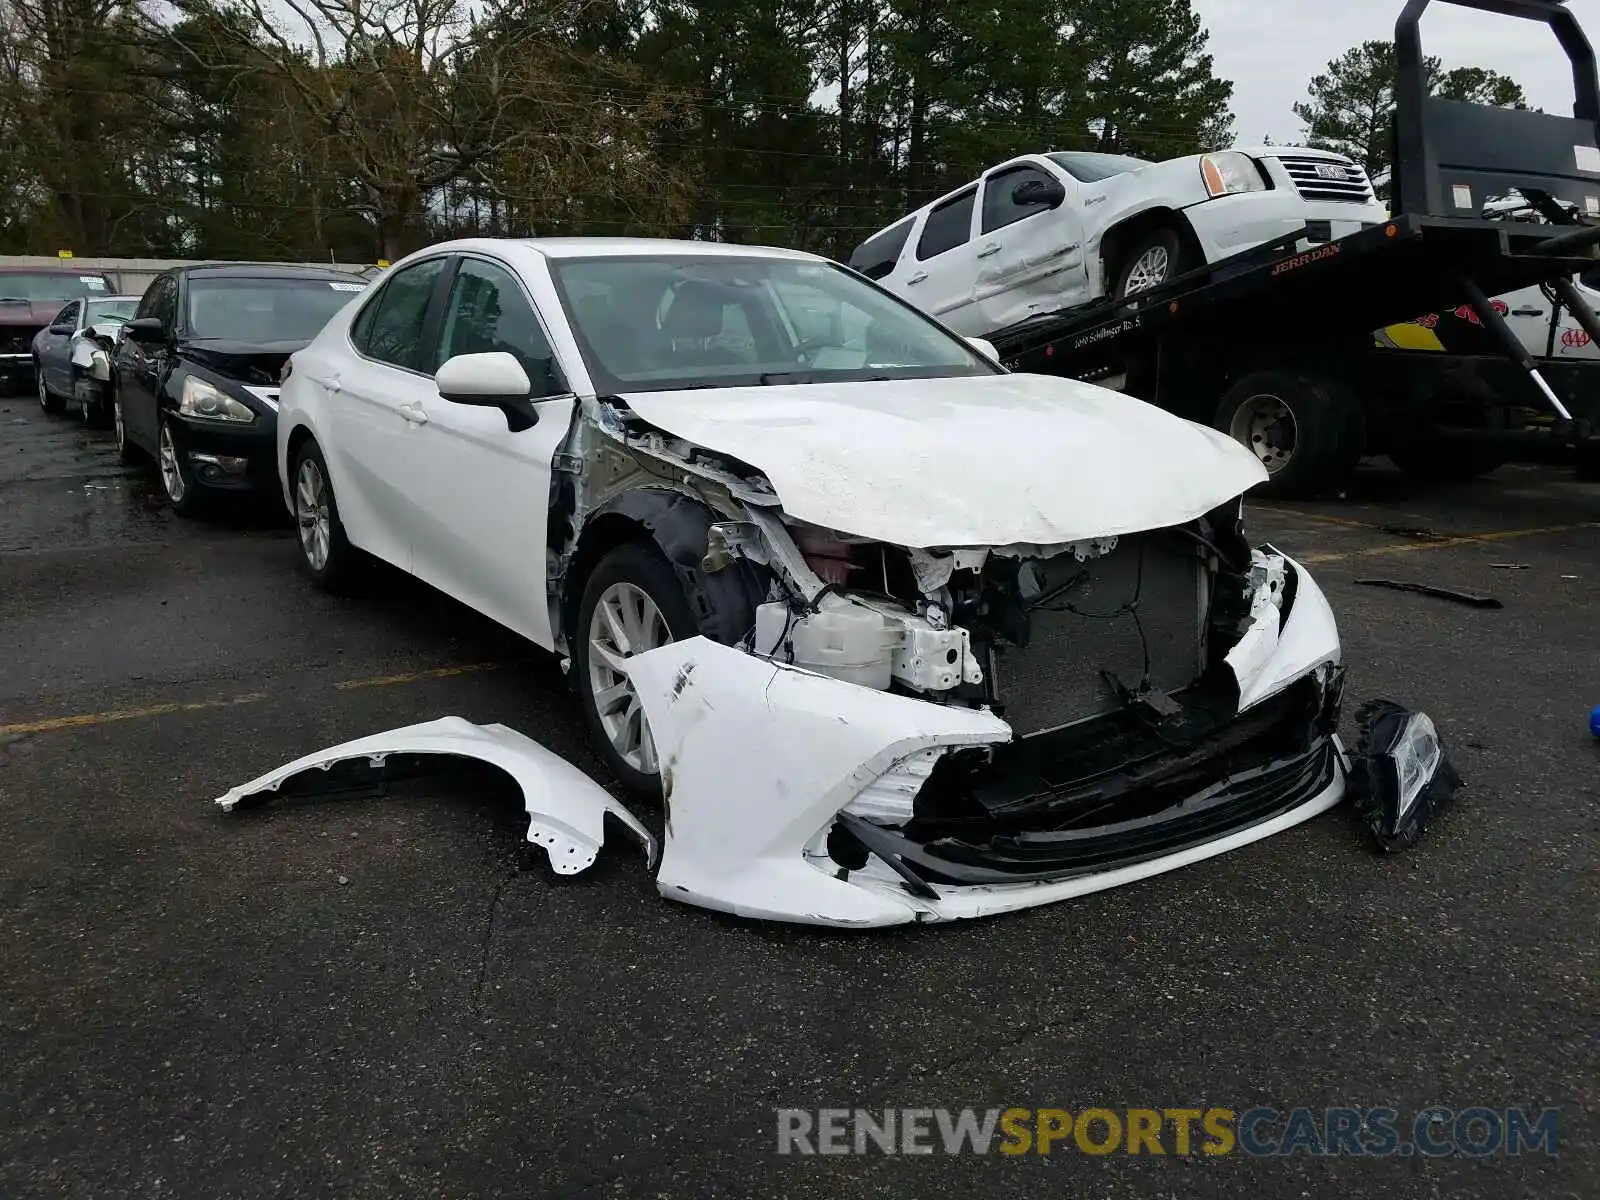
[{"x1": 850, "y1": 146, "x2": 1389, "y2": 336}]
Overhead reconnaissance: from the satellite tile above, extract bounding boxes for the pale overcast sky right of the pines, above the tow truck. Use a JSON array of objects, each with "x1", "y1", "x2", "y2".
[{"x1": 1194, "y1": 0, "x2": 1600, "y2": 144}]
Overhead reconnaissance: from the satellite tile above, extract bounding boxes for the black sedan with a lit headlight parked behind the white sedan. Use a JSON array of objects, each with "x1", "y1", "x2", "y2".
[{"x1": 112, "y1": 264, "x2": 366, "y2": 515}]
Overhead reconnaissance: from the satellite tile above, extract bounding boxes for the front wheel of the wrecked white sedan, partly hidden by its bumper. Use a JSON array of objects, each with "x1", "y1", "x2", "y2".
[{"x1": 571, "y1": 542, "x2": 698, "y2": 797}]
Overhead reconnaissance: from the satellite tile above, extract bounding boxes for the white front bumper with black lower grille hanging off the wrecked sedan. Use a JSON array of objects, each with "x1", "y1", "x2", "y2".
[{"x1": 629, "y1": 553, "x2": 1347, "y2": 926}]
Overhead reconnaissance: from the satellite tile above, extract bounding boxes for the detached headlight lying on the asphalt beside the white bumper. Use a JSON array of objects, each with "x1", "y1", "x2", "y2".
[{"x1": 1350, "y1": 701, "x2": 1461, "y2": 853}]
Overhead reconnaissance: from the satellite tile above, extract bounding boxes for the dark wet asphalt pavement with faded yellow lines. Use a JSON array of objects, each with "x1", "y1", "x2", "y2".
[{"x1": 0, "y1": 397, "x2": 1600, "y2": 1200}]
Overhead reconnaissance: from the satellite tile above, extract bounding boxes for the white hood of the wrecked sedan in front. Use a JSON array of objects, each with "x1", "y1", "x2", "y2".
[{"x1": 621, "y1": 374, "x2": 1267, "y2": 549}]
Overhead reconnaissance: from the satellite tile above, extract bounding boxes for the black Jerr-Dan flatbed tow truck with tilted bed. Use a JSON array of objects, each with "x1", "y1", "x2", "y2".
[{"x1": 987, "y1": 0, "x2": 1600, "y2": 496}]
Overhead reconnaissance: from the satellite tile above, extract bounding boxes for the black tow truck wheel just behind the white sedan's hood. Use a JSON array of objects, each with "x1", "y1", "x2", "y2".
[{"x1": 1213, "y1": 371, "x2": 1366, "y2": 496}]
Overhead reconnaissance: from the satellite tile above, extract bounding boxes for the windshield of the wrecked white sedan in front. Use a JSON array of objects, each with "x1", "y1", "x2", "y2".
[{"x1": 550, "y1": 254, "x2": 998, "y2": 392}]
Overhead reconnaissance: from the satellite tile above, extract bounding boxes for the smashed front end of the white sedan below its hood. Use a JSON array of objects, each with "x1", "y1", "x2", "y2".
[{"x1": 572, "y1": 400, "x2": 1346, "y2": 925}]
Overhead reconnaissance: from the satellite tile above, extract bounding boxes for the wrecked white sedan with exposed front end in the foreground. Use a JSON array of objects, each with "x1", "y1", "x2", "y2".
[{"x1": 272, "y1": 238, "x2": 1349, "y2": 926}]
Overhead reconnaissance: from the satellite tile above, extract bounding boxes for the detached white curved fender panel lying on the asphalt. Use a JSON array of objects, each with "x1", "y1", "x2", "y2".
[{"x1": 216, "y1": 717, "x2": 658, "y2": 875}]
